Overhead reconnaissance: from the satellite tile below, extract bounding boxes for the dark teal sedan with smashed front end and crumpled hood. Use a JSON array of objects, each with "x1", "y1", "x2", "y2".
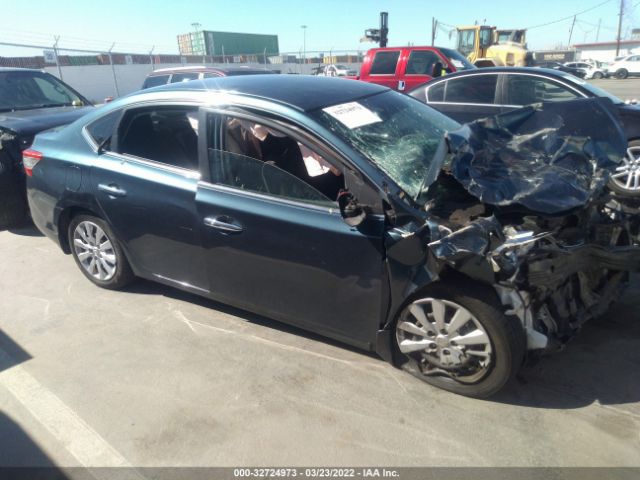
[{"x1": 24, "y1": 75, "x2": 640, "y2": 397}]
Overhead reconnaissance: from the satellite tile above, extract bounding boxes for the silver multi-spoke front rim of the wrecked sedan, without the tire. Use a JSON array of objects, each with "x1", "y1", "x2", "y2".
[{"x1": 396, "y1": 298, "x2": 493, "y2": 383}]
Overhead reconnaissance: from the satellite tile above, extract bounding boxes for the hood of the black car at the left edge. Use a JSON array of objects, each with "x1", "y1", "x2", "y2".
[{"x1": 0, "y1": 106, "x2": 95, "y2": 137}]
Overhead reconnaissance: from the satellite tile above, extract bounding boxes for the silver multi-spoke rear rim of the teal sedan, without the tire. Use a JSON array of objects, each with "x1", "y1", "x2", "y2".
[{"x1": 73, "y1": 221, "x2": 118, "y2": 281}]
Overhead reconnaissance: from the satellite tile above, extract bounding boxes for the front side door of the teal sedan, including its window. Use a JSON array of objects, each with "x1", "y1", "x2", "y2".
[{"x1": 196, "y1": 111, "x2": 384, "y2": 348}]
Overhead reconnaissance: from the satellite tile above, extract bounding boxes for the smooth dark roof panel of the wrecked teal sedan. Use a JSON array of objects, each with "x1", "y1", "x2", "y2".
[{"x1": 148, "y1": 75, "x2": 390, "y2": 111}]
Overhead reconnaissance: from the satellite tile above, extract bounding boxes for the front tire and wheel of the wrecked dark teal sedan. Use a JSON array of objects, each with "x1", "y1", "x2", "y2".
[{"x1": 393, "y1": 282, "x2": 526, "y2": 398}]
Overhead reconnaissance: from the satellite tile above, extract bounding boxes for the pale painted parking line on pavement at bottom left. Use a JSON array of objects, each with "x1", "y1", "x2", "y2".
[{"x1": 0, "y1": 349, "x2": 131, "y2": 467}]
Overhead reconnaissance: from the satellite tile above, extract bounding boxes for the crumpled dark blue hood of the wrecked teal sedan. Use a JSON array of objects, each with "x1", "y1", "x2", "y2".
[{"x1": 425, "y1": 98, "x2": 627, "y2": 215}]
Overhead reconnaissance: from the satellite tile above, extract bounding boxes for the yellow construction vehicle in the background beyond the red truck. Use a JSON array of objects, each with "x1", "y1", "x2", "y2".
[{"x1": 457, "y1": 25, "x2": 532, "y2": 67}]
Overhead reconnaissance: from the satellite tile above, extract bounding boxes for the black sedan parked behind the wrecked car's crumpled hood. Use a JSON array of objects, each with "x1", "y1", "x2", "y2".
[{"x1": 409, "y1": 67, "x2": 640, "y2": 197}]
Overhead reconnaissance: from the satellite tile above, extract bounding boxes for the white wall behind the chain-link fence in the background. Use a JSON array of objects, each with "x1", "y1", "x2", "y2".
[{"x1": 45, "y1": 63, "x2": 360, "y2": 103}]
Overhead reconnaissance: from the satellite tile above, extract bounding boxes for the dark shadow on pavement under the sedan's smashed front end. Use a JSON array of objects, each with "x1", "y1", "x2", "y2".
[{"x1": 492, "y1": 282, "x2": 640, "y2": 408}]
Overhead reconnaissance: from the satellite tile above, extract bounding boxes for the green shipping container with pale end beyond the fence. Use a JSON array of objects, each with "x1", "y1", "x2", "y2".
[{"x1": 178, "y1": 30, "x2": 280, "y2": 56}]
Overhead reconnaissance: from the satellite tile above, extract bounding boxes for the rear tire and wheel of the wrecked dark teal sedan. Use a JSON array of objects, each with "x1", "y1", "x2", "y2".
[{"x1": 68, "y1": 215, "x2": 135, "y2": 290}]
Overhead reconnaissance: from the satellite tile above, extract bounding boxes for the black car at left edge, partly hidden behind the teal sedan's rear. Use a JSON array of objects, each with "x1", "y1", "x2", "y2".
[{"x1": 0, "y1": 68, "x2": 93, "y2": 229}]
